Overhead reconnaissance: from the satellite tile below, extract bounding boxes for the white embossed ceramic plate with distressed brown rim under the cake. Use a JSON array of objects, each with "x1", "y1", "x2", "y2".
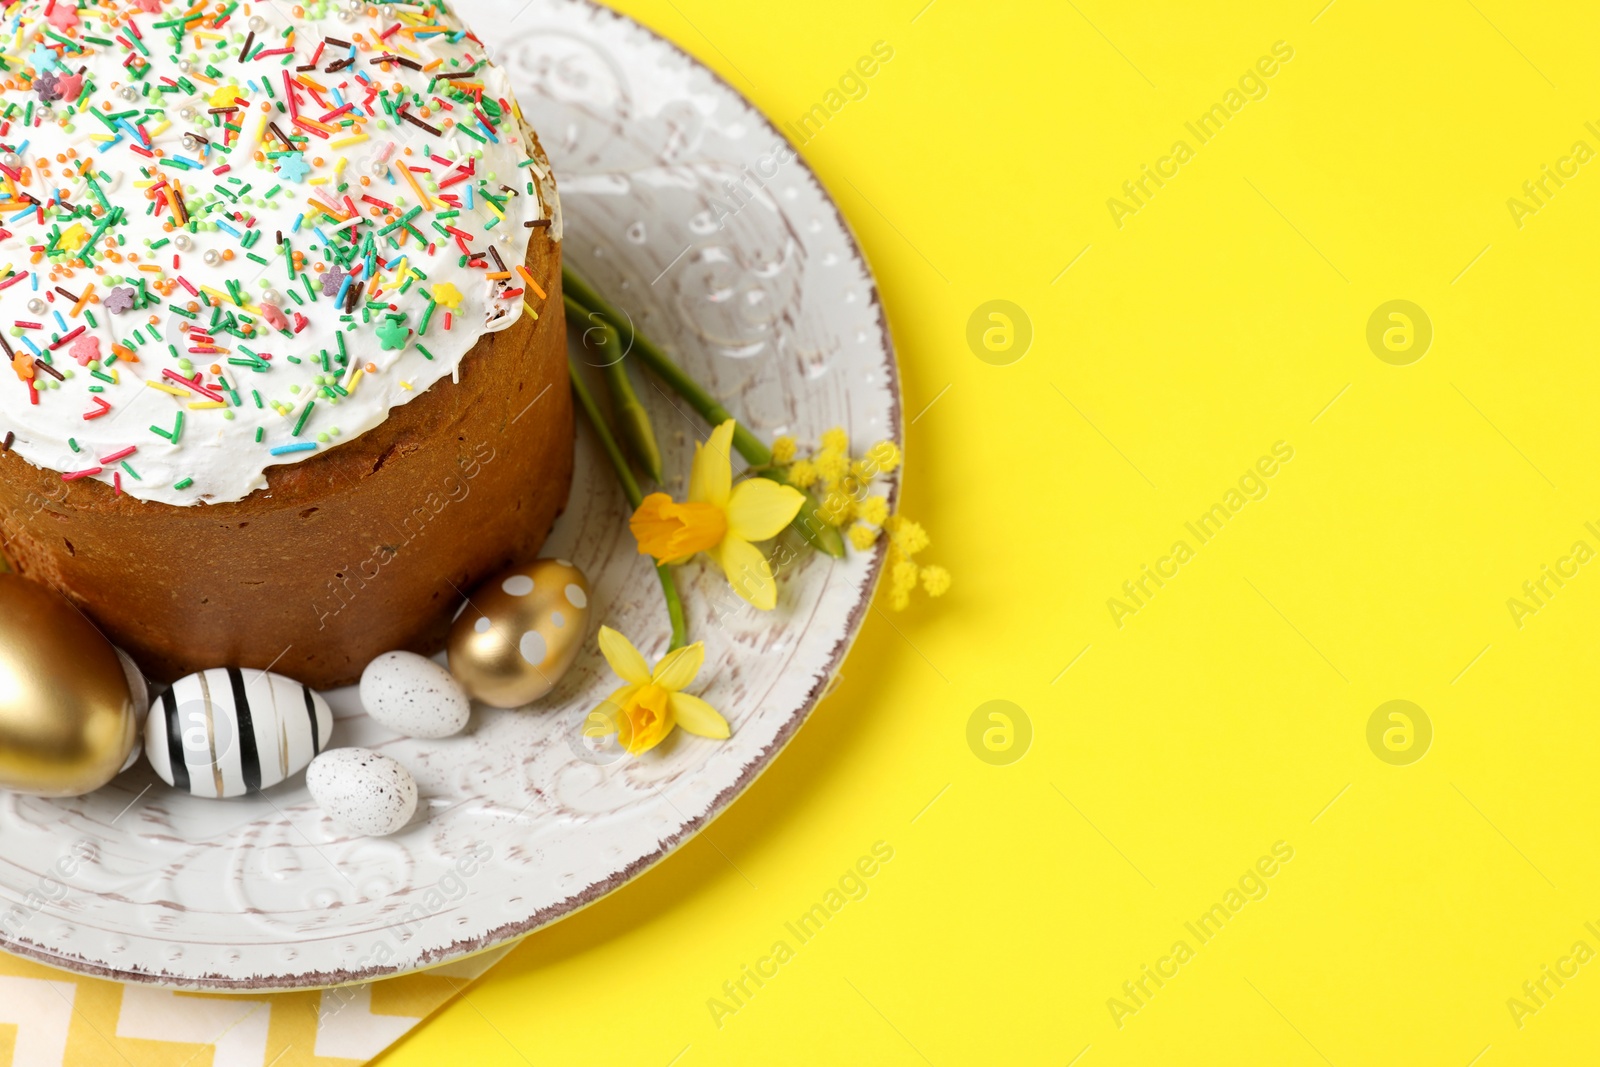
[{"x1": 0, "y1": 0, "x2": 901, "y2": 990}]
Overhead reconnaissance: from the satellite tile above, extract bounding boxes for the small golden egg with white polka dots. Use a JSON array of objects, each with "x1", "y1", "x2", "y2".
[{"x1": 450, "y1": 560, "x2": 589, "y2": 707}]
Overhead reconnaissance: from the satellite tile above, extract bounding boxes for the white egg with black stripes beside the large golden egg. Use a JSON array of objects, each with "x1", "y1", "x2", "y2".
[{"x1": 144, "y1": 667, "x2": 333, "y2": 798}]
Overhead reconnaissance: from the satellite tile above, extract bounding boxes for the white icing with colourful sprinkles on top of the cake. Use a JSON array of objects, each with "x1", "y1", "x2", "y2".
[{"x1": 0, "y1": 0, "x2": 560, "y2": 504}]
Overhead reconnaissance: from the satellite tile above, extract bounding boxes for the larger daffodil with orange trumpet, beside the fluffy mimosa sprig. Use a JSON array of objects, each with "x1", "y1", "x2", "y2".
[{"x1": 630, "y1": 419, "x2": 805, "y2": 614}]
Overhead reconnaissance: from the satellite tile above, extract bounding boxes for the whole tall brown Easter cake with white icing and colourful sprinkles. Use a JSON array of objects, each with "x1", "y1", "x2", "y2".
[{"x1": 0, "y1": 0, "x2": 573, "y2": 688}]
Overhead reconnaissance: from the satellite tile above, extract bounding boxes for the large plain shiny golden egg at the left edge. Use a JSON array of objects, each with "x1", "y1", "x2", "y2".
[{"x1": 0, "y1": 574, "x2": 147, "y2": 797}]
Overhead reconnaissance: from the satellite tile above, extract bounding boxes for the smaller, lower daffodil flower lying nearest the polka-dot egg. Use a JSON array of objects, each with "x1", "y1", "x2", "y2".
[{"x1": 584, "y1": 625, "x2": 728, "y2": 755}]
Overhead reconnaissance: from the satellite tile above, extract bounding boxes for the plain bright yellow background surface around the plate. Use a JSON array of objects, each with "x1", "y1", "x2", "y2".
[{"x1": 382, "y1": 0, "x2": 1600, "y2": 1067}]
